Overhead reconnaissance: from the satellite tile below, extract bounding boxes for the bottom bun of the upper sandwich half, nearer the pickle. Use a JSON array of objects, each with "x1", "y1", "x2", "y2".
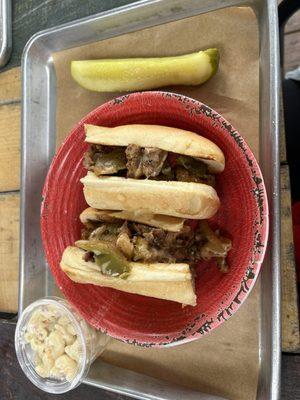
[{"x1": 81, "y1": 172, "x2": 220, "y2": 219}]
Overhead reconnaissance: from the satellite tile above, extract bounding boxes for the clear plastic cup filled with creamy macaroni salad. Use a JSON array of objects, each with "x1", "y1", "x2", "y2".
[{"x1": 15, "y1": 297, "x2": 109, "y2": 394}]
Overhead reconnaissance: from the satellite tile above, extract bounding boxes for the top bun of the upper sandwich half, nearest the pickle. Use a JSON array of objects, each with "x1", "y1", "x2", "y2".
[{"x1": 84, "y1": 124, "x2": 225, "y2": 173}]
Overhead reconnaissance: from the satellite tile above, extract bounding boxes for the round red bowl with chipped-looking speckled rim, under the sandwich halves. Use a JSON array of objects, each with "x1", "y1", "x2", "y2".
[{"x1": 41, "y1": 92, "x2": 268, "y2": 347}]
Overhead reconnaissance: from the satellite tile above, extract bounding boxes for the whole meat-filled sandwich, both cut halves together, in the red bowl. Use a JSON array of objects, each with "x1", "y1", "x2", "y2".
[{"x1": 61, "y1": 125, "x2": 231, "y2": 306}]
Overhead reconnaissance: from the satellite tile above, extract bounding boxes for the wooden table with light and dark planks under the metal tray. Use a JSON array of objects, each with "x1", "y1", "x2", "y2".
[{"x1": 0, "y1": 0, "x2": 300, "y2": 400}]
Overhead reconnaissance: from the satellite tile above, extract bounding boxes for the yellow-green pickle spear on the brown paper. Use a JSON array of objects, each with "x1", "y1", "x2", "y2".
[{"x1": 71, "y1": 48, "x2": 219, "y2": 92}]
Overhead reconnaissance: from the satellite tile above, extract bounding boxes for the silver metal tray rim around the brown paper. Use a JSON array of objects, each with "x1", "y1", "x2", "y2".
[{"x1": 19, "y1": 0, "x2": 281, "y2": 400}]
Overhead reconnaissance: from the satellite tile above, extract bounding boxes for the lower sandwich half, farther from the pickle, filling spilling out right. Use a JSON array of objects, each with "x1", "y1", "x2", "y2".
[{"x1": 61, "y1": 208, "x2": 231, "y2": 306}]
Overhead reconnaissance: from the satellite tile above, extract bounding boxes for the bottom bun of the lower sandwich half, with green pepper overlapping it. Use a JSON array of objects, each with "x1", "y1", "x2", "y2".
[{"x1": 60, "y1": 246, "x2": 196, "y2": 306}]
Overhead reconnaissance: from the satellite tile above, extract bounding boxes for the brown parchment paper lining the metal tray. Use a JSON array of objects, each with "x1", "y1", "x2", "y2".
[{"x1": 53, "y1": 7, "x2": 260, "y2": 400}]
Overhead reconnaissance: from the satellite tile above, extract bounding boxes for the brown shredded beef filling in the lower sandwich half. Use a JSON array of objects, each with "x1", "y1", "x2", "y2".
[{"x1": 82, "y1": 220, "x2": 231, "y2": 272}]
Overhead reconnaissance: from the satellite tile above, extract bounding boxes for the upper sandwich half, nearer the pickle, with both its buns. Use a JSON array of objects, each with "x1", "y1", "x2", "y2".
[{"x1": 81, "y1": 124, "x2": 225, "y2": 219}]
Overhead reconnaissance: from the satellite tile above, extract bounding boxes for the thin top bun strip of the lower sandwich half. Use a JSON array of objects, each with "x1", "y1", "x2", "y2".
[{"x1": 80, "y1": 207, "x2": 184, "y2": 232}]
